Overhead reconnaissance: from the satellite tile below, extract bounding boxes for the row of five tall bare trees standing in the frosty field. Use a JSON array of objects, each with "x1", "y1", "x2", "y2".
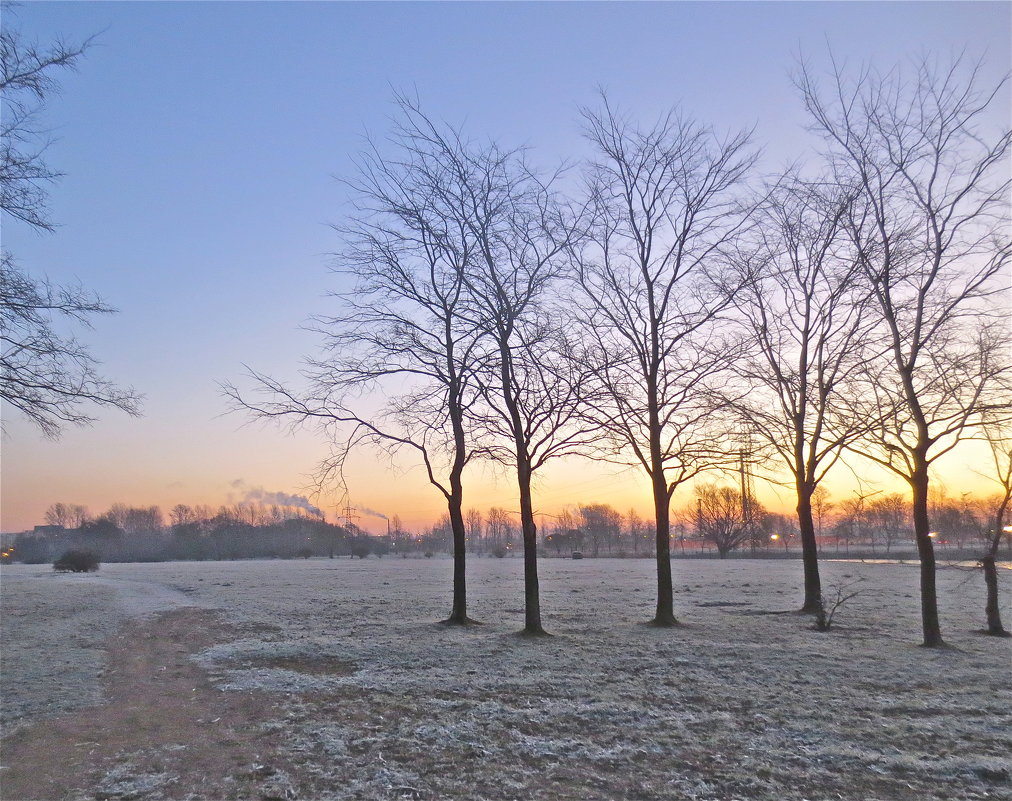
[{"x1": 226, "y1": 53, "x2": 1012, "y2": 646}]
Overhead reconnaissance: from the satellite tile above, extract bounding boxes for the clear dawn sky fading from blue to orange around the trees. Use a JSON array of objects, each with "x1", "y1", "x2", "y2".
[{"x1": 0, "y1": 2, "x2": 1012, "y2": 531}]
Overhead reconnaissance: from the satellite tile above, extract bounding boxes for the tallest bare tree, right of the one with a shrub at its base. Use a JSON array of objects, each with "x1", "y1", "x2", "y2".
[{"x1": 796, "y1": 53, "x2": 1012, "y2": 647}]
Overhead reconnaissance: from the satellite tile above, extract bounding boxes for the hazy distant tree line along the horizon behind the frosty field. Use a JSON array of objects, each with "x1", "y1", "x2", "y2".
[{"x1": 5, "y1": 482, "x2": 1012, "y2": 563}]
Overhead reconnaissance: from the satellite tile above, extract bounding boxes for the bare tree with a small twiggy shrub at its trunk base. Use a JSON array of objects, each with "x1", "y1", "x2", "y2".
[{"x1": 730, "y1": 175, "x2": 868, "y2": 612}]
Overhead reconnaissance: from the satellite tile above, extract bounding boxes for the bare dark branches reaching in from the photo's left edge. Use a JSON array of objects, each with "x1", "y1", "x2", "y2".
[{"x1": 0, "y1": 21, "x2": 140, "y2": 437}]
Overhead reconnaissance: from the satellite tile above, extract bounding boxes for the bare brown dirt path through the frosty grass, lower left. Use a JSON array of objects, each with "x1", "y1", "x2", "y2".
[{"x1": 0, "y1": 609, "x2": 299, "y2": 801}]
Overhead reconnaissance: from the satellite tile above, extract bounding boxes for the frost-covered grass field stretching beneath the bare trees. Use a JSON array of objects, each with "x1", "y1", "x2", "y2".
[{"x1": 0, "y1": 557, "x2": 1012, "y2": 801}]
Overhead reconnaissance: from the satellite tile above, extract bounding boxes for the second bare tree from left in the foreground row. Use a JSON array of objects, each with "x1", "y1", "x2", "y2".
[{"x1": 458, "y1": 160, "x2": 596, "y2": 635}]
